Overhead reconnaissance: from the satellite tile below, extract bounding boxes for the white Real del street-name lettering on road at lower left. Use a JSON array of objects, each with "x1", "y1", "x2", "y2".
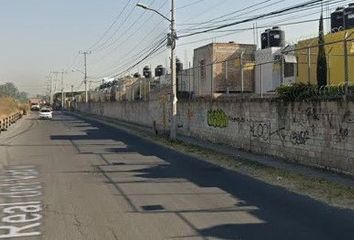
[{"x1": 0, "y1": 166, "x2": 43, "y2": 239}]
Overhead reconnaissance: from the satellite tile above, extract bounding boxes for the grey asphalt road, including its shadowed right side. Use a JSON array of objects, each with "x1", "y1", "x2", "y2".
[{"x1": 0, "y1": 111, "x2": 354, "y2": 240}]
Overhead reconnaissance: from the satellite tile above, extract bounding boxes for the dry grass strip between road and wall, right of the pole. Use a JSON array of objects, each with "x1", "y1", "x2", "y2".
[{"x1": 164, "y1": 139, "x2": 354, "y2": 209}]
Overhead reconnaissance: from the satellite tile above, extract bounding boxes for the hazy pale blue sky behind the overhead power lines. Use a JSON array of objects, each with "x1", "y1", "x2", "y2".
[{"x1": 0, "y1": 0, "x2": 351, "y2": 95}]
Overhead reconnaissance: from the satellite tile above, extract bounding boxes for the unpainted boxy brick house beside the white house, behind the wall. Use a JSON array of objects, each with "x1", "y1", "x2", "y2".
[{"x1": 193, "y1": 42, "x2": 256, "y2": 96}]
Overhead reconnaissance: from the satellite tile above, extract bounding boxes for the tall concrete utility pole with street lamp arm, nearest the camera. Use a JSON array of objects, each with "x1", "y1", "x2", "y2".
[{"x1": 136, "y1": 0, "x2": 178, "y2": 141}]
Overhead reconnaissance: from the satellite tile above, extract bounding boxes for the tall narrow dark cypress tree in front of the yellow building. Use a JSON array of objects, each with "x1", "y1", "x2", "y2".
[{"x1": 317, "y1": 12, "x2": 327, "y2": 88}]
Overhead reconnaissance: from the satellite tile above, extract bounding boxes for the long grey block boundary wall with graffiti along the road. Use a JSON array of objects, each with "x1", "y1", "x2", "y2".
[{"x1": 77, "y1": 98, "x2": 354, "y2": 175}]
